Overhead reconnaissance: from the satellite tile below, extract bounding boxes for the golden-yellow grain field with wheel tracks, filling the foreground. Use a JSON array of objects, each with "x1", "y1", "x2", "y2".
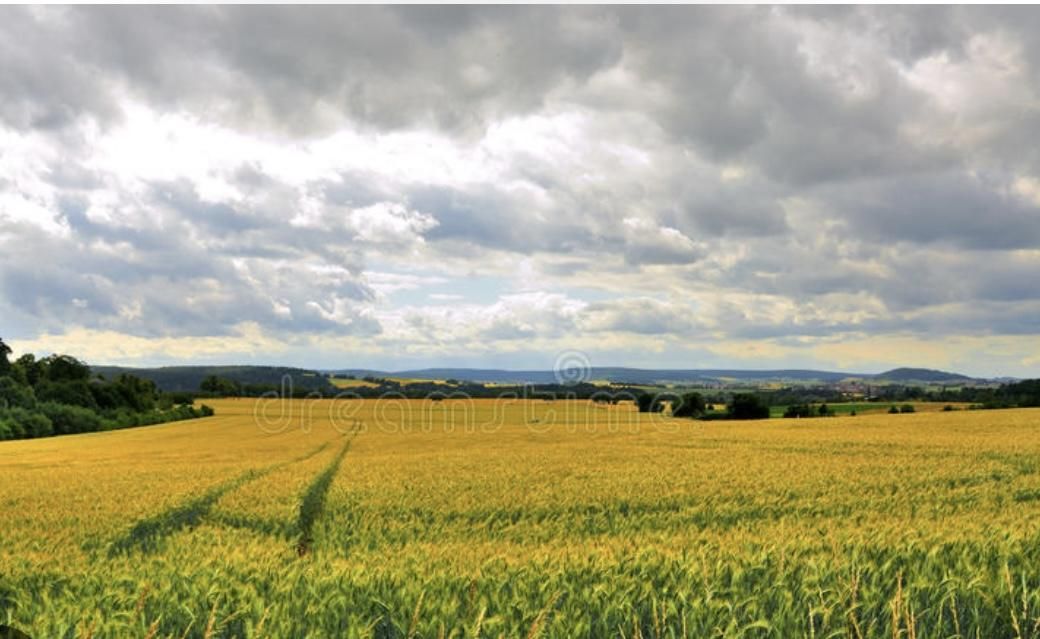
[{"x1": 0, "y1": 400, "x2": 1040, "y2": 637}]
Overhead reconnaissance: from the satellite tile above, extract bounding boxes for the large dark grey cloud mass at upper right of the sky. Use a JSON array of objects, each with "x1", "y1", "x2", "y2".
[{"x1": 611, "y1": 7, "x2": 947, "y2": 184}]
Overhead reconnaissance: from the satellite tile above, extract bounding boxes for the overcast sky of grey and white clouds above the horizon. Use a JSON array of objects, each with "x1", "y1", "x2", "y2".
[{"x1": 0, "y1": 6, "x2": 1040, "y2": 376}]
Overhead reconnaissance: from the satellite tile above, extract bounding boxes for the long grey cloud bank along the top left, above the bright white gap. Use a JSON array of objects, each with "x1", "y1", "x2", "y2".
[{"x1": 0, "y1": 6, "x2": 621, "y2": 133}]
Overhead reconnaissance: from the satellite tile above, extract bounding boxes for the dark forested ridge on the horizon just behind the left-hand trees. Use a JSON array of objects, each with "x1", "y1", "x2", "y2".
[{"x1": 90, "y1": 366, "x2": 333, "y2": 391}]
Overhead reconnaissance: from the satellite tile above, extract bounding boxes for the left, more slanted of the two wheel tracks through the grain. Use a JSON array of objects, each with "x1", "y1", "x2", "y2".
[{"x1": 108, "y1": 440, "x2": 330, "y2": 557}]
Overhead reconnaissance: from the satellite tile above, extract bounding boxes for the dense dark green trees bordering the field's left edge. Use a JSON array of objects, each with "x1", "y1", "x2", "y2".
[{"x1": 0, "y1": 339, "x2": 213, "y2": 440}]
